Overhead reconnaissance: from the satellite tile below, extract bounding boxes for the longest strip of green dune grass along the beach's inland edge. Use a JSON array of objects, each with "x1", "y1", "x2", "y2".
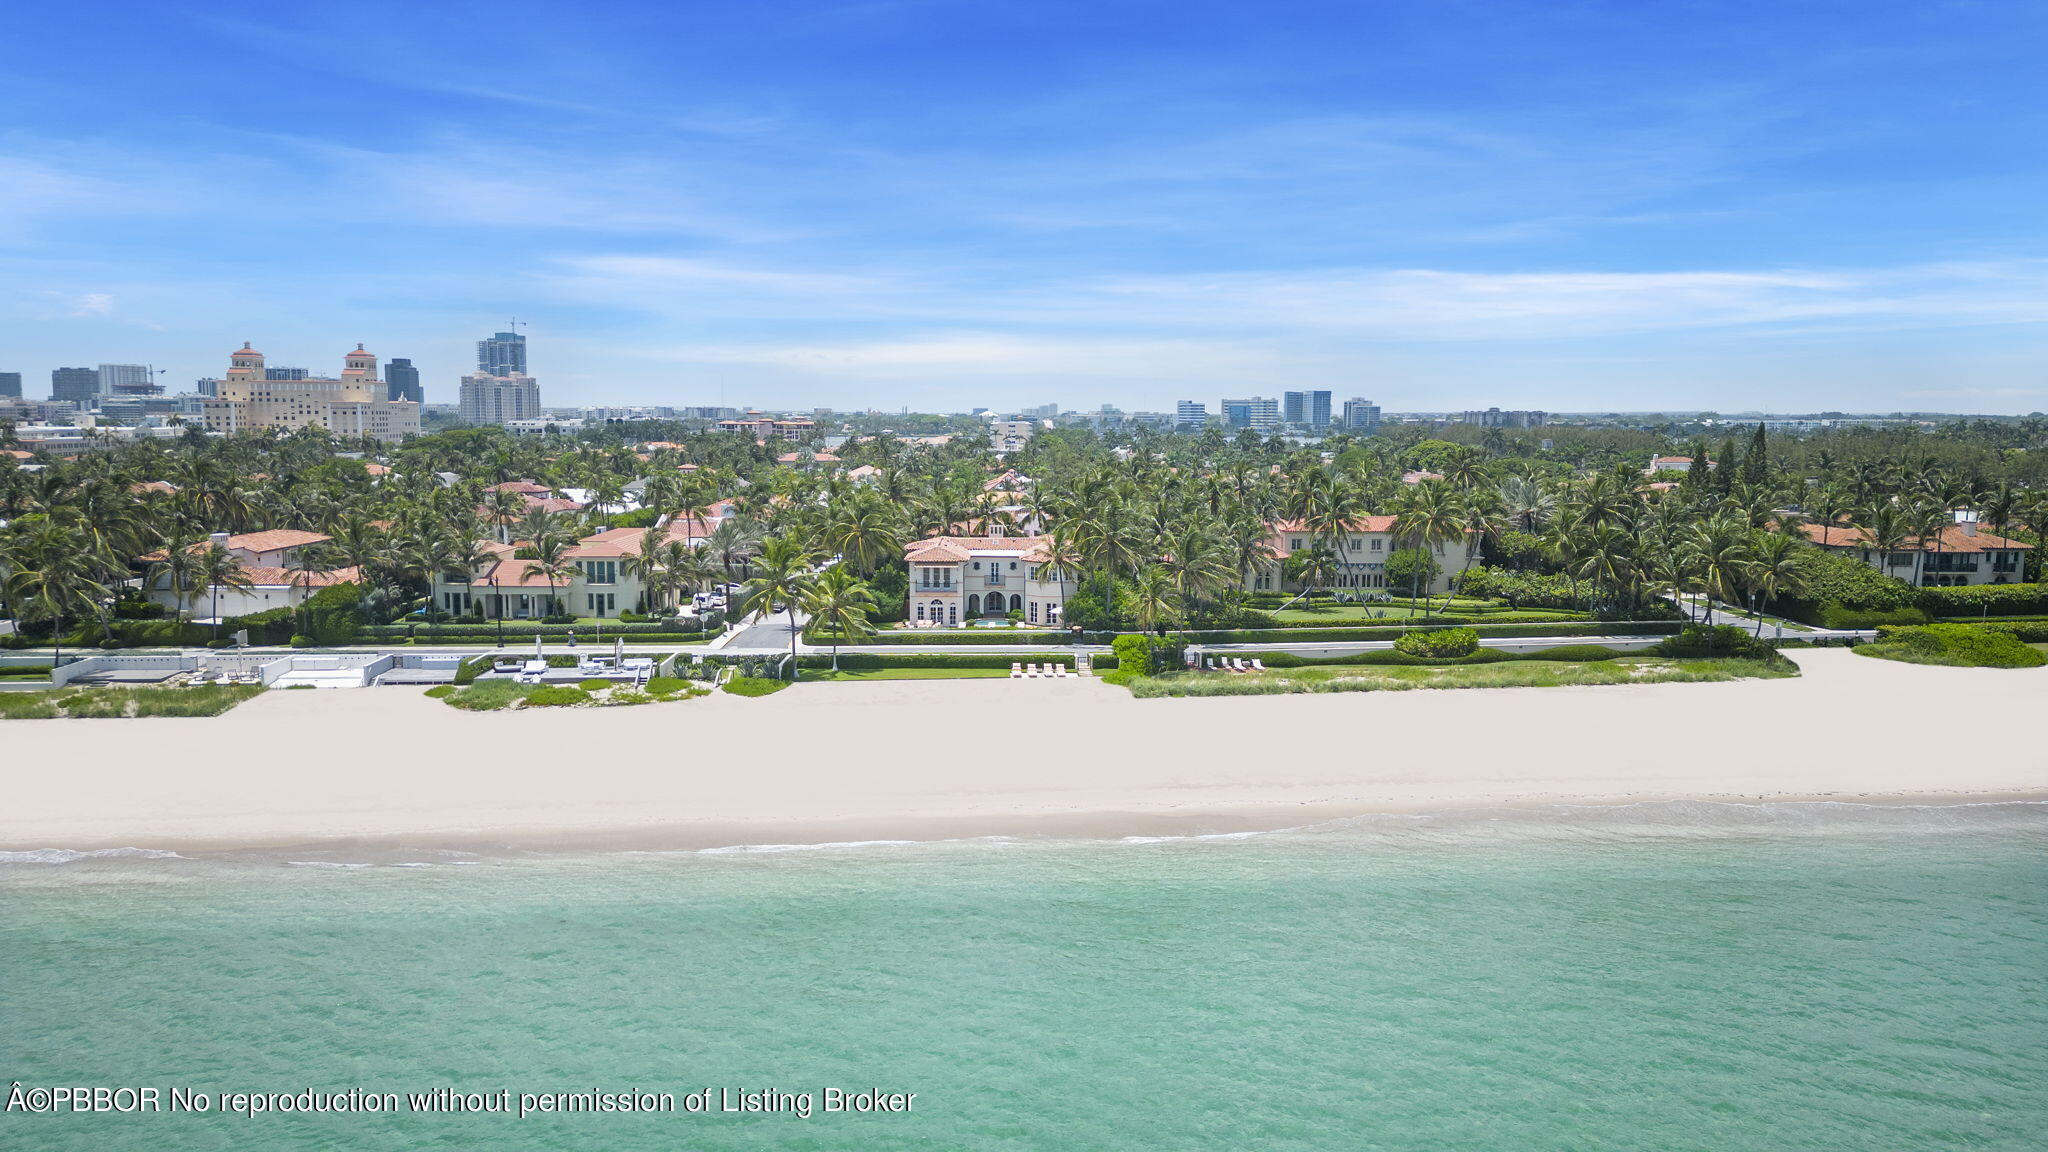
[{"x1": 1128, "y1": 656, "x2": 1798, "y2": 699}]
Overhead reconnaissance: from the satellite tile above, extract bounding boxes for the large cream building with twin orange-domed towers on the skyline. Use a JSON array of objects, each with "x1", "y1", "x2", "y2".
[{"x1": 201, "y1": 342, "x2": 420, "y2": 441}]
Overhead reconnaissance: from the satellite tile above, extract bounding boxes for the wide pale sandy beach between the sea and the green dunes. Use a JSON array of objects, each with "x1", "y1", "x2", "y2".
[{"x1": 0, "y1": 650, "x2": 2048, "y2": 851}]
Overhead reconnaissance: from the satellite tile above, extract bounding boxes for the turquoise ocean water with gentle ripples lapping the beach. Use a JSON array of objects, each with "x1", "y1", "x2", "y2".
[{"x1": 0, "y1": 804, "x2": 2048, "y2": 1152}]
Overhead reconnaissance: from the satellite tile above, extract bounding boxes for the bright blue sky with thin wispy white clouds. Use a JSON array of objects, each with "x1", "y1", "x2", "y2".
[{"x1": 0, "y1": 0, "x2": 2048, "y2": 412}]
